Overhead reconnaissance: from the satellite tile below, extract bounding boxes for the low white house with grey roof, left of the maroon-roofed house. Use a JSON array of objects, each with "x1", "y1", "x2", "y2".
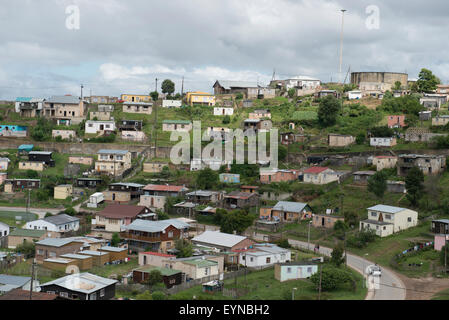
[{"x1": 24, "y1": 214, "x2": 80, "y2": 233}]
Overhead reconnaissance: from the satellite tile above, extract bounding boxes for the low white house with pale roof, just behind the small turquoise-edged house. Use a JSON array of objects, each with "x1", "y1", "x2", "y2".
[{"x1": 239, "y1": 243, "x2": 291, "y2": 268}]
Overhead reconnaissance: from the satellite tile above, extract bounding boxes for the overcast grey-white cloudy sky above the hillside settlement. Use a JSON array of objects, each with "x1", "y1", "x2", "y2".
[{"x1": 0, "y1": 0, "x2": 449, "y2": 99}]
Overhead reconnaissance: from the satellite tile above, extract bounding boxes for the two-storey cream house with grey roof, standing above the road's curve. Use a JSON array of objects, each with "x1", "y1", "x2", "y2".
[{"x1": 360, "y1": 204, "x2": 418, "y2": 237}]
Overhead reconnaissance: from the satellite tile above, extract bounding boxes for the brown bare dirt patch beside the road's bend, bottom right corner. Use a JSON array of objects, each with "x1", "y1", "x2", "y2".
[{"x1": 396, "y1": 273, "x2": 449, "y2": 300}]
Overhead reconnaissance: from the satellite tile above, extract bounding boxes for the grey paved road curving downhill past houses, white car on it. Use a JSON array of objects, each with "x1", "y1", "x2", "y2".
[{"x1": 288, "y1": 239, "x2": 406, "y2": 300}]
